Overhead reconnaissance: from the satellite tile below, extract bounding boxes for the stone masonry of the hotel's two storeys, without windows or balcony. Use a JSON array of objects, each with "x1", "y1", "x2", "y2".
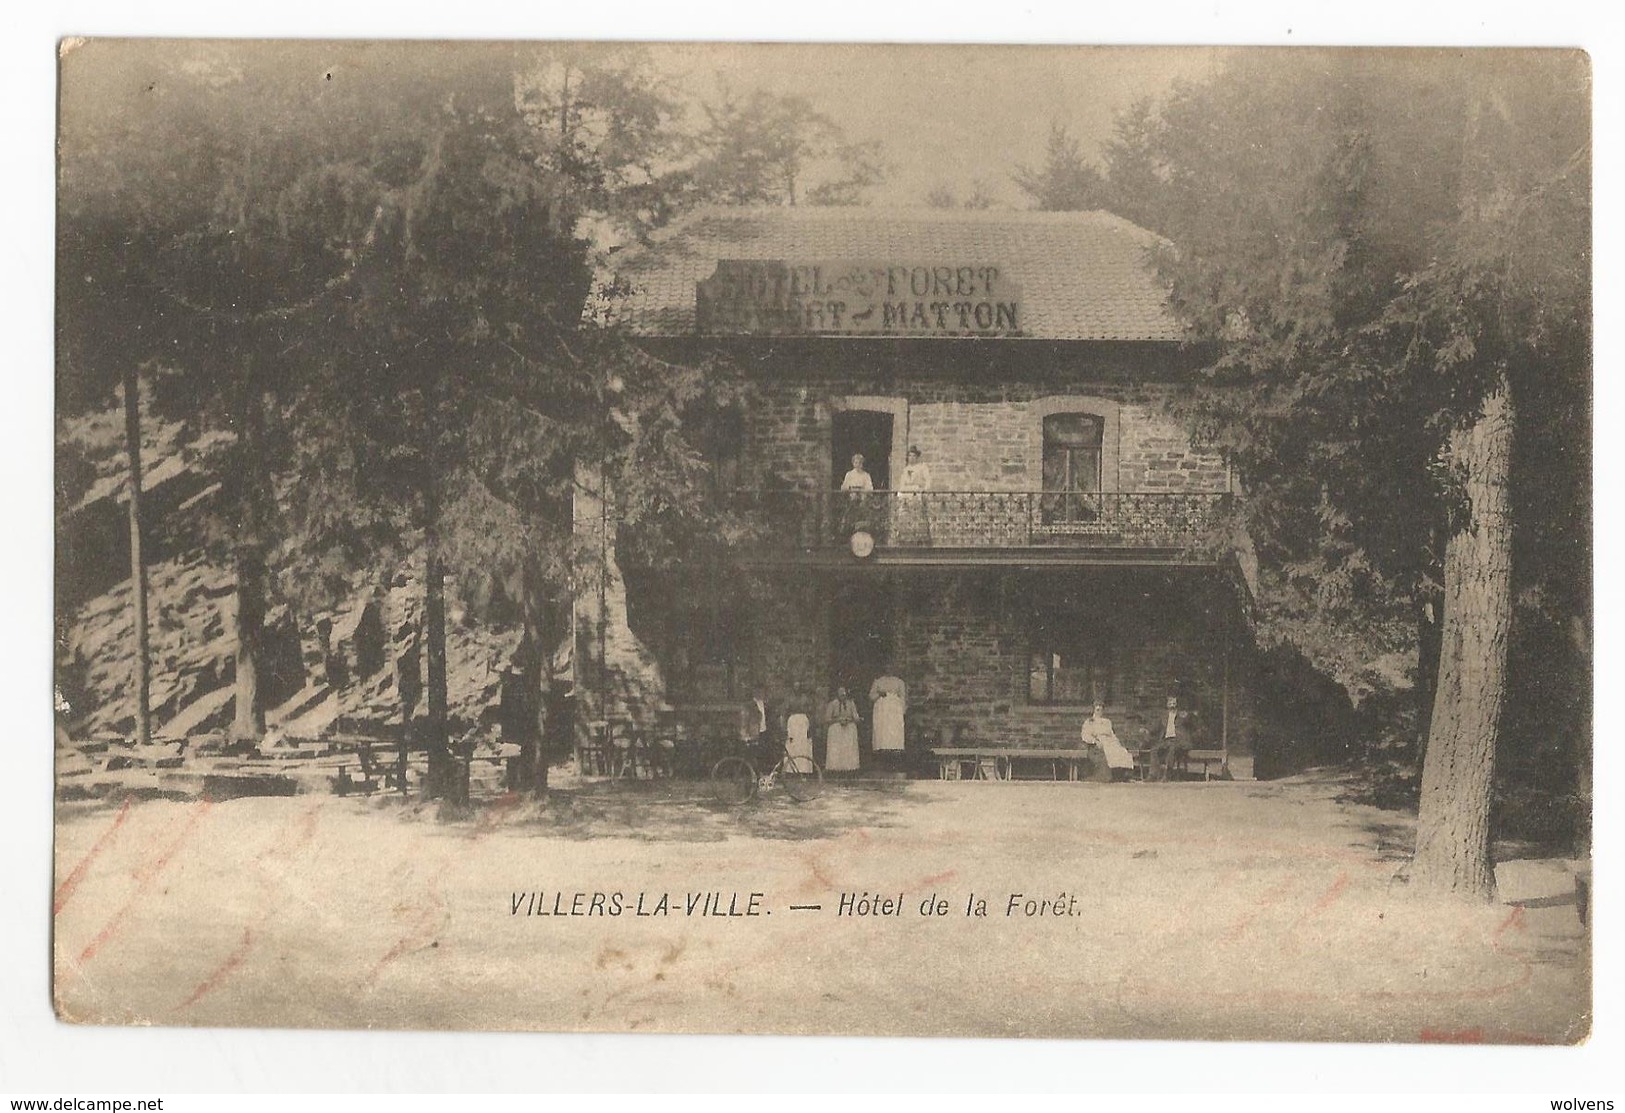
[{"x1": 604, "y1": 337, "x2": 1240, "y2": 744}]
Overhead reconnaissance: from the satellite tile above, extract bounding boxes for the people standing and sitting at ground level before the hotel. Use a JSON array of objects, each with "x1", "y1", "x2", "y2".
[{"x1": 739, "y1": 674, "x2": 1196, "y2": 780}]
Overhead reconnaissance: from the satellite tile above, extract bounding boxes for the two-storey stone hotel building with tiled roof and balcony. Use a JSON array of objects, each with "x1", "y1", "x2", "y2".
[{"x1": 577, "y1": 206, "x2": 1251, "y2": 766}]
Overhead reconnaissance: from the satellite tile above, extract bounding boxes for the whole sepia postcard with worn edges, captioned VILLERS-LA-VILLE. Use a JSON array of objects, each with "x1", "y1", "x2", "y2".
[{"x1": 47, "y1": 37, "x2": 1594, "y2": 1052}]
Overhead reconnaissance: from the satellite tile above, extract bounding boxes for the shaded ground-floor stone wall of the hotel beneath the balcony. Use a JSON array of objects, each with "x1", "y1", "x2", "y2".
[{"x1": 679, "y1": 569, "x2": 1248, "y2": 752}]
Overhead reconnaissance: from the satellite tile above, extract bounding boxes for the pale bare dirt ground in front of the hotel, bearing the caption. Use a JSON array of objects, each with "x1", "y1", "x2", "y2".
[{"x1": 54, "y1": 777, "x2": 1591, "y2": 1043}]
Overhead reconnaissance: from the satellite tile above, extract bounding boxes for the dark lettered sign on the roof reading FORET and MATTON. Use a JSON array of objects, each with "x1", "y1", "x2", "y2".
[{"x1": 694, "y1": 258, "x2": 1022, "y2": 336}]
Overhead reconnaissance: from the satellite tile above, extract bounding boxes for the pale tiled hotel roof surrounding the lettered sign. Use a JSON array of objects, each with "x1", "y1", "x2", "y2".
[{"x1": 613, "y1": 206, "x2": 1180, "y2": 340}]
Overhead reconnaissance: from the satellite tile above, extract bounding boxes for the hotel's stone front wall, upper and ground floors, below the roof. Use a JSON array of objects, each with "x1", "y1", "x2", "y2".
[{"x1": 583, "y1": 337, "x2": 1248, "y2": 752}]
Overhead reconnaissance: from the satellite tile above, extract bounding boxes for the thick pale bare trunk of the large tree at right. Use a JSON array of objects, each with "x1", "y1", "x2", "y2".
[{"x1": 1411, "y1": 379, "x2": 1513, "y2": 900}]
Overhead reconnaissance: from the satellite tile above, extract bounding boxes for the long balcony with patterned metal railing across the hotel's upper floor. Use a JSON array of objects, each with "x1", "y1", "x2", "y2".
[{"x1": 736, "y1": 491, "x2": 1230, "y2": 561}]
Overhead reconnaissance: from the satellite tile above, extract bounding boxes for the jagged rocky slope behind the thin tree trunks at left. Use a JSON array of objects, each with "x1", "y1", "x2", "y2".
[{"x1": 55, "y1": 393, "x2": 539, "y2": 739}]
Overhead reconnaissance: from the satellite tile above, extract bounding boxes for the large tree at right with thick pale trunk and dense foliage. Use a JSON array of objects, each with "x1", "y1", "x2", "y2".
[{"x1": 1110, "y1": 52, "x2": 1589, "y2": 897}]
